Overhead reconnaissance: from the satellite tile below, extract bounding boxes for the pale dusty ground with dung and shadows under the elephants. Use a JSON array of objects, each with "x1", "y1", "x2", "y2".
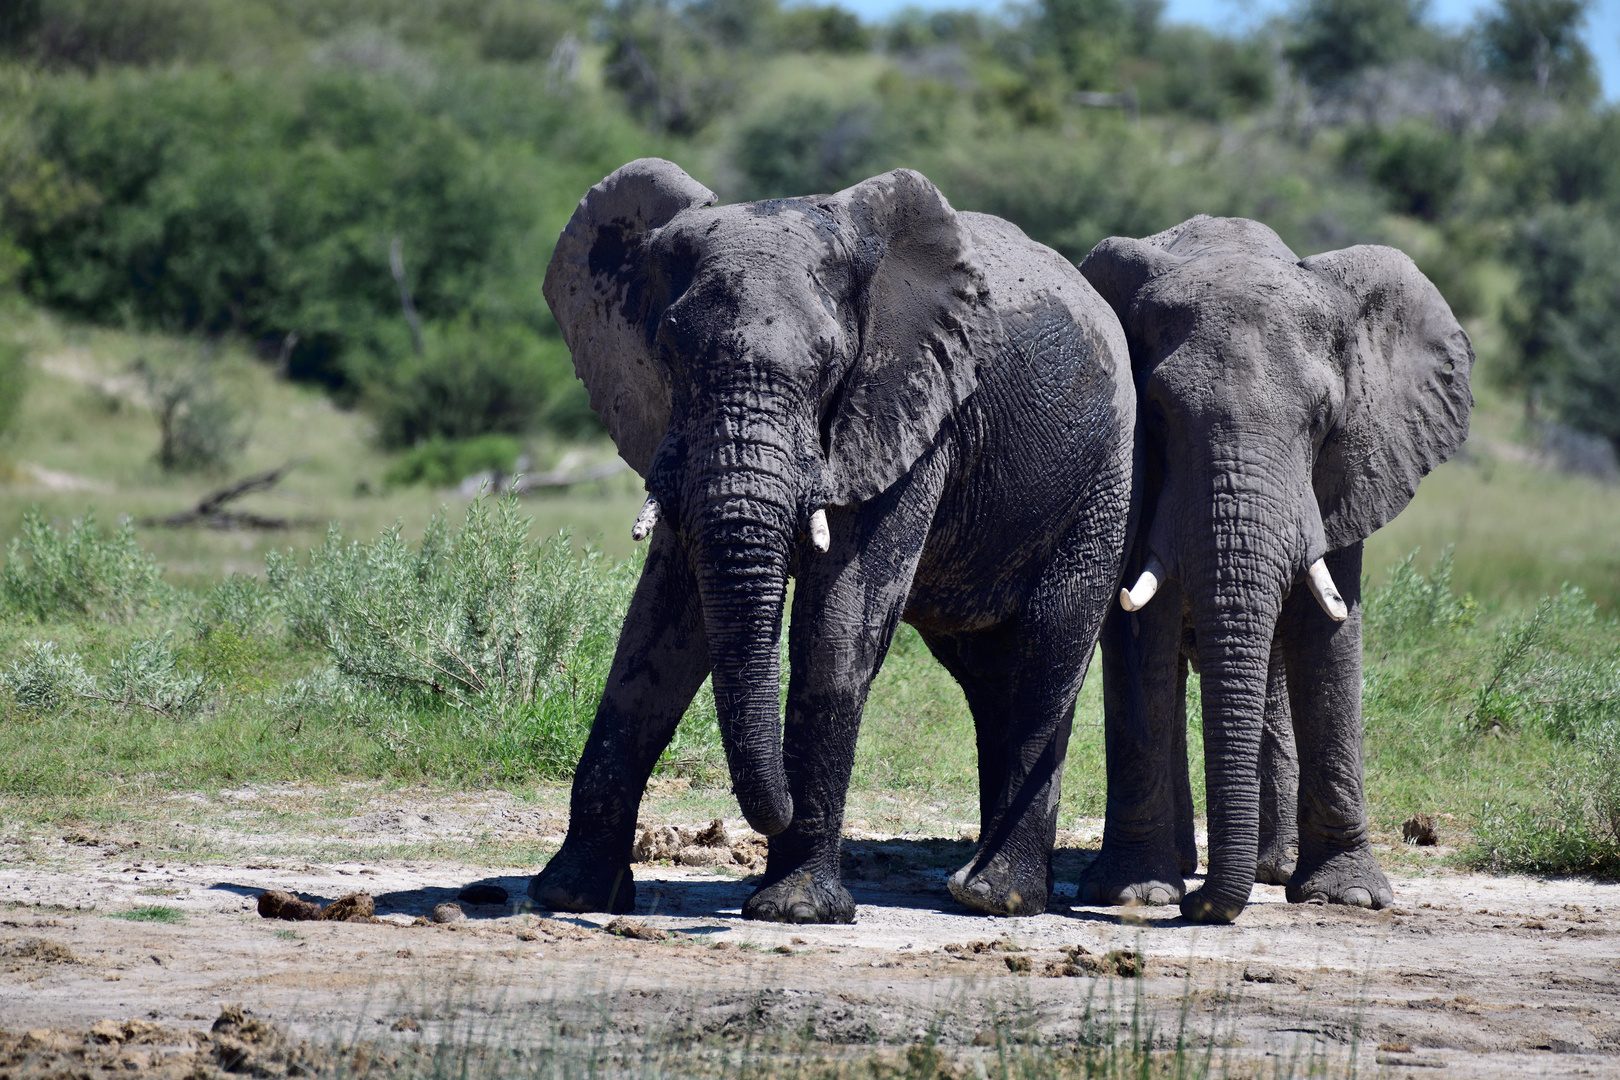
[{"x1": 0, "y1": 795, "x2": 1620, "y2": 1077}]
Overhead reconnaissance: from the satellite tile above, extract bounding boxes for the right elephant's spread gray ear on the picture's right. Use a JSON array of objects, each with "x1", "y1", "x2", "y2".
[{"x1": 1299, "y1": 244, "x2": 1474, "y2": 549}]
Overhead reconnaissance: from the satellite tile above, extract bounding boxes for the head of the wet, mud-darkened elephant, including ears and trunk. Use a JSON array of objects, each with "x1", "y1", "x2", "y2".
[{"x1": 544, "y1": 159, "x2": 1001, "y2": 836}]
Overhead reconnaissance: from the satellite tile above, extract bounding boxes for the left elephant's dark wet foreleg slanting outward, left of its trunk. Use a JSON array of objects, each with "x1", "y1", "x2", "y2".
[{"x1": 528, "y1": 528, "x2": 710, "y2": 913}]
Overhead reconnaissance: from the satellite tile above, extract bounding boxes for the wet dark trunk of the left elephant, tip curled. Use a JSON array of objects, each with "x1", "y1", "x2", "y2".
[{"x1": 685, "y1": 447, "x2": 799, "y2": 836}]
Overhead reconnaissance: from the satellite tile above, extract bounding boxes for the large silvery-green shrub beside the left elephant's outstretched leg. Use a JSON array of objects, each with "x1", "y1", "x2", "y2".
[{"x1": 269, "y1": 499, "x2": 718, "y2": 777}]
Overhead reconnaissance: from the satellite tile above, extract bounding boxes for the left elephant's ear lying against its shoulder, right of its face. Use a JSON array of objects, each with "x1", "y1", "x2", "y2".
[{"x1": 825, "y1": 168, "x2": 1001, "y2": 505}]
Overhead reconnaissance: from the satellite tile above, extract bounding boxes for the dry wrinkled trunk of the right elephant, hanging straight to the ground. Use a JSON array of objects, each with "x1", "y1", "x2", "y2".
[{"x1": 1178, "y1": 459, "x2": 1302, "y2": 923}]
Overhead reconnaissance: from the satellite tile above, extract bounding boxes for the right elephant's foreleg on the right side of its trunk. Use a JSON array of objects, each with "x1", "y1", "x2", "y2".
[{"x1": 1277, "y1": 542, "x2": 1395, "y2": 908}]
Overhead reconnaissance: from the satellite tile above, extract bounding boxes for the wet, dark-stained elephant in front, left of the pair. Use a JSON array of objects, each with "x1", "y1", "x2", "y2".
[{"x1": 530, "y1": 160, "x2": 1136, "y2": 923}]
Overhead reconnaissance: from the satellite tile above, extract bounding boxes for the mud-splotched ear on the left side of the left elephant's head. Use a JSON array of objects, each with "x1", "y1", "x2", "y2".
[{"x1": 544, "y1": 157, "x2": 716, "y2": 476}]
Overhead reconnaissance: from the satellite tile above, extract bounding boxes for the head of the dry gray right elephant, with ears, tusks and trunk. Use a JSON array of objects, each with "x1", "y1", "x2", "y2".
[{"x1": 1081, "y1": 217, "x2": 1474, "y2": 920}]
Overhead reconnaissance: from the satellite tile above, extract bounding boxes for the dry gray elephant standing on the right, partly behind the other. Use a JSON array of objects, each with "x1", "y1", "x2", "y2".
[{"x1": 1079, "y1": 217, "x2": 1474, "y2": 921}]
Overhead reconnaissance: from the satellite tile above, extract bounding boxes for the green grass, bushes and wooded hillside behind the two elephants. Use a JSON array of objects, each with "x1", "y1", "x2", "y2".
[{"x1": 0, "y1": 0, "x2": 1620, "y2": 873}]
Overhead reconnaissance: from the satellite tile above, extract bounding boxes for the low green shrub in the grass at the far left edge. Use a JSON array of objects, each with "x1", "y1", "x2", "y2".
[{"x1": 0, "y1": 508, "x2": 170, "y2": 622}]
